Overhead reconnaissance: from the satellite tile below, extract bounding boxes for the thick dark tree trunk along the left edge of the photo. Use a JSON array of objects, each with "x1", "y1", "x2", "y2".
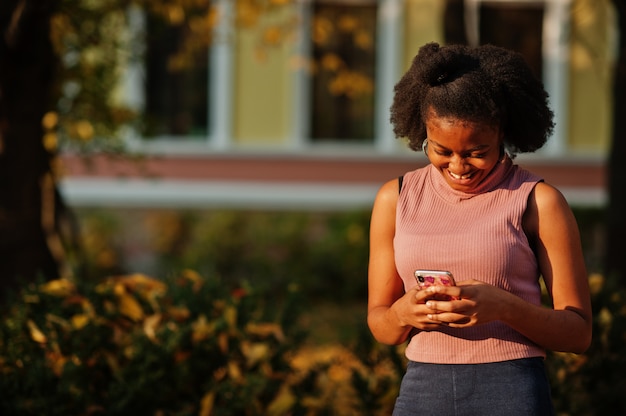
[{"x1": 0, "y1": 0, "x2": 59, "y2": 292}]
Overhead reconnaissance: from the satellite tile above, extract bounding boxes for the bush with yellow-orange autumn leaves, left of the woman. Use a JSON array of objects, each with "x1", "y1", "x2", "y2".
[{"x1": 0, "y1": 271, "x2": 399, "y2": 415}]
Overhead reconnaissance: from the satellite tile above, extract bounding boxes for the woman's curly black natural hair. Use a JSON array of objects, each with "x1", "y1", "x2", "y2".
[{"x1": 391, "y1": 42, "x2": 554, "y2": 157}]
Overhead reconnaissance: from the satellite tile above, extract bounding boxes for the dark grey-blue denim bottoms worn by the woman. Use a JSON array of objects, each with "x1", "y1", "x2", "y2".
[{"x1": 393, "y1": 357, "x2": 554, "y2": 416}]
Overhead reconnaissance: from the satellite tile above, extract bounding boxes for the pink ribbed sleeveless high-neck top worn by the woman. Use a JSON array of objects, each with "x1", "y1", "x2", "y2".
[{"x1": 394, "y1": 157, "x2": 545, "y2": 364}]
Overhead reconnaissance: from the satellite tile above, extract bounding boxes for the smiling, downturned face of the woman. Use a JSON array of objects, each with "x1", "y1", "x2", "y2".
[{"x1": 426, "y1": 112, "x2": 502, "y2": 192}]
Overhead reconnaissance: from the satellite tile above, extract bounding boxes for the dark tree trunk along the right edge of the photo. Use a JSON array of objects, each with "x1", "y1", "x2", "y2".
[{"x1": 605, "y1": 0, "x2": 626, "y2": 286}]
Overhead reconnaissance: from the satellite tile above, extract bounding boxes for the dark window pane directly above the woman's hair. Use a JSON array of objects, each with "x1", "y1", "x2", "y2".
[{"x1": 480, "y1": 2, "x2": 544, "y2": 79}]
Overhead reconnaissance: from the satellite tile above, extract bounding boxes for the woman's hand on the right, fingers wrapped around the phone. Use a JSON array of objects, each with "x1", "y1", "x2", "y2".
[{"x1": 425, "y1": 280, "x2": 514, "y2": 328}]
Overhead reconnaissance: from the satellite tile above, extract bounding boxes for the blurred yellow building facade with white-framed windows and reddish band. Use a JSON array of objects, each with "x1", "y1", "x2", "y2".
[{"x1": 61, "y1": 0, "x2": 616, "y2": 209}]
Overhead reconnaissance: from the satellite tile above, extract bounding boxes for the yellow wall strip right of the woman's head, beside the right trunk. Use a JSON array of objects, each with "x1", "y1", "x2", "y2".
[{"x1": 568, "y1": 0, "x2": 614, "y2": 153}]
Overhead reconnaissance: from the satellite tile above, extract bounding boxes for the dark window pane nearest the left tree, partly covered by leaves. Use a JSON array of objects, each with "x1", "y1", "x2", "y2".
[{"x1": 144, "y1": 12, "x2": 209, "y2": 138}]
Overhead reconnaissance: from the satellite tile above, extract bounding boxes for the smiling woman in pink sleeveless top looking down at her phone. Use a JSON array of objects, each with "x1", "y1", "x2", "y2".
[{"x1": 368, "y1": 43, "x2": 591, "y2": 416}]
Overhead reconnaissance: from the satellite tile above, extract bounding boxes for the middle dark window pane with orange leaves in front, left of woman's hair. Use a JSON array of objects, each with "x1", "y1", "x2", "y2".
[{"x1": 311, "y1": 2, "x2": 376, "y2": 142}]
